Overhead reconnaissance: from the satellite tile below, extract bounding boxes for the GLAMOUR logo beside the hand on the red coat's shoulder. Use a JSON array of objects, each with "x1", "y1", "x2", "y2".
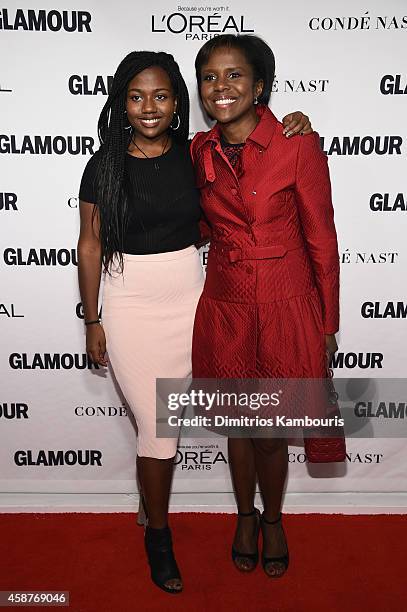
[{"x1": 320, "y1": 136, "x2": 403, "y2": 155}]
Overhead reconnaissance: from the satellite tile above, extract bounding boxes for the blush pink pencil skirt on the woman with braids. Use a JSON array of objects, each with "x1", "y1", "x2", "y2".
[{"x1": 102, "y1": 246, "x2": 203, "y2": 459}]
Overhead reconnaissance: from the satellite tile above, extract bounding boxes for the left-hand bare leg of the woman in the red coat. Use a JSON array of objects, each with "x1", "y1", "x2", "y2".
[{"x1": 228, "y1": 438, "x2": 258, "y2": 571}]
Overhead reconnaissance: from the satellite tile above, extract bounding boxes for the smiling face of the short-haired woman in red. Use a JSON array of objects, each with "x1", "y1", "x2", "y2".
[{"x1": 200, "y1": 47, "x2": 263, "y2": 124}]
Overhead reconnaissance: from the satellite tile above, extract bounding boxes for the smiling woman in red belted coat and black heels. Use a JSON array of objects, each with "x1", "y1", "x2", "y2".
[{"x1": 191, "y1": 35, "x2": 339, "y2": 577}]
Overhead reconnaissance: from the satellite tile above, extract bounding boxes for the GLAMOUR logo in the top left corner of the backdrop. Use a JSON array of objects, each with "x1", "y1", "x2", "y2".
[{"x1": 0, "y1": 9, "x2": 92, "y2": 32}]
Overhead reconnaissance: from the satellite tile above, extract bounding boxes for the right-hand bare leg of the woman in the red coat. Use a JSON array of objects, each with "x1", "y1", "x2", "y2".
[{"x1": 253, "y1": 438, "x2": 288, "y2": 576}]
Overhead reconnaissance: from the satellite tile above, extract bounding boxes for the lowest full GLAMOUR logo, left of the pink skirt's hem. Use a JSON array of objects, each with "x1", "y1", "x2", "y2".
[{"x1": 14, "y1": 449, "x2": 102, "y2": 467}]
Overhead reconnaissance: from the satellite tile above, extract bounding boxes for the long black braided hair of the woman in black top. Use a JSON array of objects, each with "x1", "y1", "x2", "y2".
[{"x1": 94, "y1": 51, "x2": 189, "y2": 273}]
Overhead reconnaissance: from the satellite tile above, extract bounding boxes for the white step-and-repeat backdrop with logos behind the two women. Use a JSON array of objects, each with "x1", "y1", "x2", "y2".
[{"x1": 0, "y1": 0, "x2": 407, "y2": 509}]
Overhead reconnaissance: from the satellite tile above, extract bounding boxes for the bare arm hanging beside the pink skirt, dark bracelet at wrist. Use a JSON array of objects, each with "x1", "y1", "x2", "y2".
[{"x1": 78, "y1": 200, "x2": 107, "y2": 365}]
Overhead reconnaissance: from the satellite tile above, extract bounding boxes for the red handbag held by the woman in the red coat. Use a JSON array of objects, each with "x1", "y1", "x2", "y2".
[{"x1": 304, "y1": 356, "x2": 346, "y2": 463}]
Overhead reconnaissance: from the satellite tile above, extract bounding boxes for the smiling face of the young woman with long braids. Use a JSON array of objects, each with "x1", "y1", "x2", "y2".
[{"x1": 126, "y1": 66, "x2": 177, "y2": 140}]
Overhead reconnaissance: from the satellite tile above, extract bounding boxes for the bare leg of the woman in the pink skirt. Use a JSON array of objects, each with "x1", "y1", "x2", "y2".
[{"x1": 137, "y1": 455, "x2": 182, "y2": 589}]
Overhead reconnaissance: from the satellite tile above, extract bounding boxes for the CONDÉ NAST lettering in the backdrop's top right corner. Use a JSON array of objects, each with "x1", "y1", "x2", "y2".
[{"x1": 308, "y1": 11, "x2": 407, "y2": 31}]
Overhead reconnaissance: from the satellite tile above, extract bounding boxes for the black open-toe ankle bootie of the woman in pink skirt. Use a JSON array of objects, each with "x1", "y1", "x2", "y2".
[{"x1": 144, "y1": 525, "x2": 182, "y2": 593}]
